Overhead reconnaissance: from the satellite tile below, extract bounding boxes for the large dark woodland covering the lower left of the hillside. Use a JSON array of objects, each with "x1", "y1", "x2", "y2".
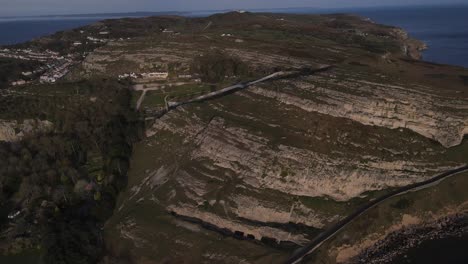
[{"x1": 0, "y1": 80, "x2": 141, "y2": 263}]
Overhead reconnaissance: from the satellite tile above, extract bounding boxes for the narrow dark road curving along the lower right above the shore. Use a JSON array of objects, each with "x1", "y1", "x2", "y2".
[{"x1": 286, "y1": 165, "x2": 468, "y2": 264}]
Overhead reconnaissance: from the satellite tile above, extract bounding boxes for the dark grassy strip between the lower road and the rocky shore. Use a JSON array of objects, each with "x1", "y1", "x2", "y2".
[{"x1": 307, "y1": 170, "x2": 468, "y2": 263}]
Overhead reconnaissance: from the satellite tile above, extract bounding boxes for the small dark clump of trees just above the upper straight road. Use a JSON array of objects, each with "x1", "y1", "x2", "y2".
[{"x1": 192, "y1": 50, "x2": 250, "y2": 83}]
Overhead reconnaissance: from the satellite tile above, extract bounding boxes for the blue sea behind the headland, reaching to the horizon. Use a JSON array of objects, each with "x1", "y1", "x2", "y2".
[{"x1": 0, "y1": 5, "x2": 468, "y2": 68}]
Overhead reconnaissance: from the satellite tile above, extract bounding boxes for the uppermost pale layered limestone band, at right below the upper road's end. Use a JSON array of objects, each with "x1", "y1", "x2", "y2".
[{"x1": 253, "y1": 70, "x2": 468, "y2": 148}]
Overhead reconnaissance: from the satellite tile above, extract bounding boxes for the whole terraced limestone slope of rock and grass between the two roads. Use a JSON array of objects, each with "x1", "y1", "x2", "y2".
[{"x1": 107, "y1": 62, "x2": 468, "y2": 254}]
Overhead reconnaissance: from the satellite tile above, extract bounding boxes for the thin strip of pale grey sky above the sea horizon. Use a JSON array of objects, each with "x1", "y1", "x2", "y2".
[{"x1": 0, "y1": 0, "x2": 468, "y2": 16}]
